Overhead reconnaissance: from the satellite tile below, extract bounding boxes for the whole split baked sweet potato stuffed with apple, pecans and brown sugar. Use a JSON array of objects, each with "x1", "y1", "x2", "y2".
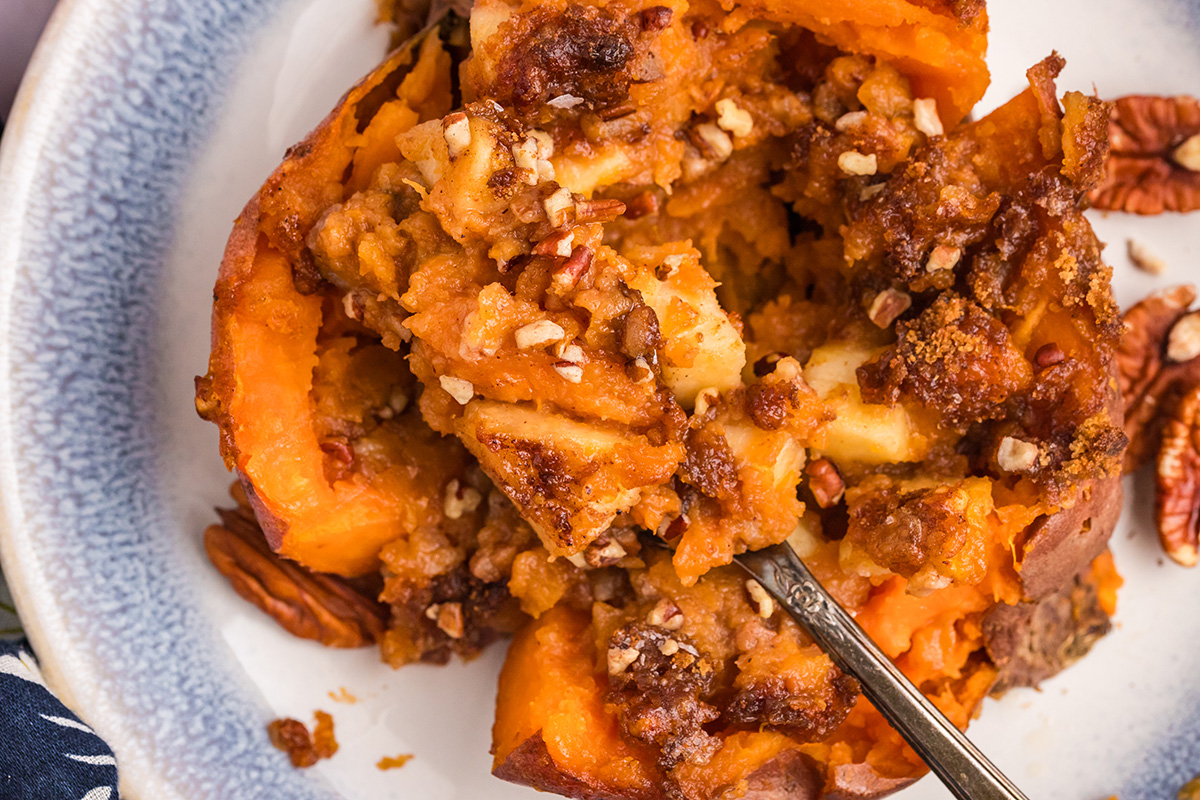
[{"x1": 197, "y1": 0, "x2": 1124, "y2": 800}]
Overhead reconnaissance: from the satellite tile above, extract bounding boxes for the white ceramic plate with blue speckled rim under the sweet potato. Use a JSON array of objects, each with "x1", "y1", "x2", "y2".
[{"x1": 0, "y1": 0, "x2": 1200, "y2": 800}]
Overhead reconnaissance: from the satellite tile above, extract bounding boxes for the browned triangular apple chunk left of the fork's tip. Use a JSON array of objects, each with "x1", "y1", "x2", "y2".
[{"x1": 458, "y1": 399, "x2": 684, "y2": 555}]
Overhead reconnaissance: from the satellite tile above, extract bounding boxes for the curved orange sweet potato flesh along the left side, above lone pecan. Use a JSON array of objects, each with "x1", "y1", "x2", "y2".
[{"x1": 197, "y1": 23, "x2": 467, "y2": 576}]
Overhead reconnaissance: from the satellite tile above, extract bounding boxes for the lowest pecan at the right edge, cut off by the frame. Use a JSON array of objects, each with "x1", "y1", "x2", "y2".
[{"x1": 1154, "y1": 385, "x2": 1200, "y2": 566}]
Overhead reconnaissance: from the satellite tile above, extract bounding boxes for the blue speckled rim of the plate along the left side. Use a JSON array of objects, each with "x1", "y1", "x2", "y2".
[{"x1": 0, "y1": 0, "x2": 332, "y2": 800}]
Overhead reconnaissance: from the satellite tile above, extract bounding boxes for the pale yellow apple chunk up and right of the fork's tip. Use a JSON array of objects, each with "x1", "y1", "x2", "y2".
[{"x1": 804, "y1": 342, "x2": 928, "y2": 464}]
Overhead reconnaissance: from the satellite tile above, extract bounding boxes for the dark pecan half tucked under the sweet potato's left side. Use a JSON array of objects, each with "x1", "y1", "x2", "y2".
[{"x1": 204, "y1": 509, "x2": 388, "y2": 648}]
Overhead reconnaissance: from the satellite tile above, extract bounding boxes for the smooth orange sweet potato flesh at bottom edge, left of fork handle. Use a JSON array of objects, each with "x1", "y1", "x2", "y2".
[{"x1": 492, "y1": 607, "x2": 916, "y2": 800}]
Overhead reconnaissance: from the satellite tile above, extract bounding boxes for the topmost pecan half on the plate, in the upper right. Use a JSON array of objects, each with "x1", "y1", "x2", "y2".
[{"x1": 1090, "y1": 95, "x2": 1200, "y2": 215}]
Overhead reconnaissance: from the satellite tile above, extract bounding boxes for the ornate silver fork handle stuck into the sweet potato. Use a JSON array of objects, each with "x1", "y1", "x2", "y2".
[{"x1": 737, "y1": 545, "x2": 1027, "y2": 800}]
